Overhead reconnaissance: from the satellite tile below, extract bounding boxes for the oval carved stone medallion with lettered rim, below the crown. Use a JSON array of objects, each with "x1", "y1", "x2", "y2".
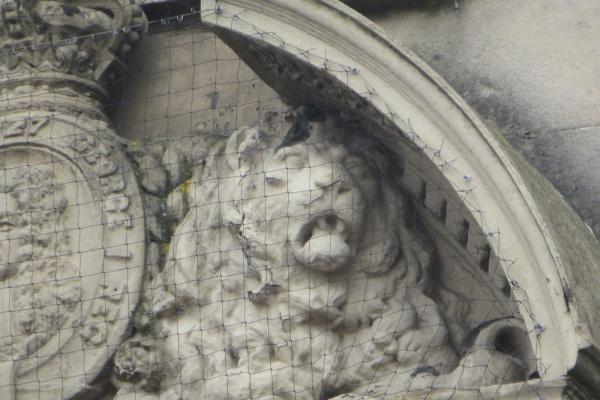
[{"x1": 0, "y1": 112, "x2": 145, "y2": 399}]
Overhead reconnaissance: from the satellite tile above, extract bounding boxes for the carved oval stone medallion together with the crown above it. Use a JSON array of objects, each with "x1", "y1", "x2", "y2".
[{"x1": 0, "y1": 0, "x2": 145, "y2": 399}]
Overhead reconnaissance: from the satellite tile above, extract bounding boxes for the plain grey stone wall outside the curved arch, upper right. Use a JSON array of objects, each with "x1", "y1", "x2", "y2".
[{"x1": 356, "y1": 0, "x2": 600, "y2": 236}]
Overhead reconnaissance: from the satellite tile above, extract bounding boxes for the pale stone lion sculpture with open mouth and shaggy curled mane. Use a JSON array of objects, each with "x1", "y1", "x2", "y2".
[{"x1": 115, "y1": 107, "x2": 523, "y2": 399}]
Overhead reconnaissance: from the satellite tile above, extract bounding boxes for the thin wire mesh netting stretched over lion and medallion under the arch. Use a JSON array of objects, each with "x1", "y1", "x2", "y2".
[{"x1": 0, "y1": 0, "x2": 544, "y2": 399}]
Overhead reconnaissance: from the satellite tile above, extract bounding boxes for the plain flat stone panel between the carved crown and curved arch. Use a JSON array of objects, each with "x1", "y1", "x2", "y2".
[{"x1": 111, "y1": 29, "x2": 281, "y2": 144}]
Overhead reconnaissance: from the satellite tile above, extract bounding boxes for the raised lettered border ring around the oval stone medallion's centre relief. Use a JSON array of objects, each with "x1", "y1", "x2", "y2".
[{"x1": 0, "y1": 111, "x2": 145, "y2": 398}]
